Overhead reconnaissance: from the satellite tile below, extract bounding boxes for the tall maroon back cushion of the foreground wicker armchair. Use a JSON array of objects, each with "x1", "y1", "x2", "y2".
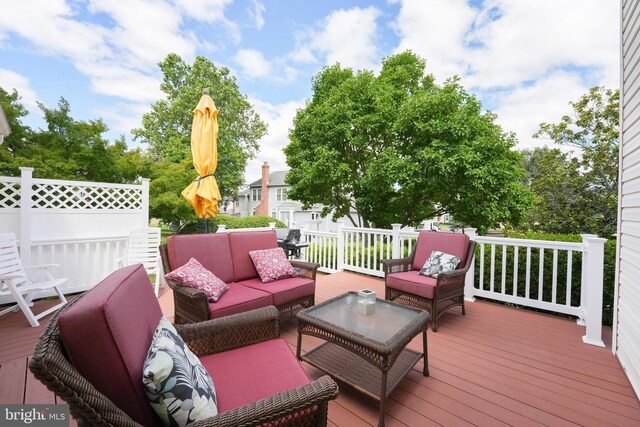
[{"x1": 58, "y1": 264, "x2": 162, "y2": 425}]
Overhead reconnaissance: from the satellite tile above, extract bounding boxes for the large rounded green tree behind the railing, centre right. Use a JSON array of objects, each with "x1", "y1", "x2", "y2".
[{"x1": 285, "y1": 52, "x2": 530, "y2": 229}]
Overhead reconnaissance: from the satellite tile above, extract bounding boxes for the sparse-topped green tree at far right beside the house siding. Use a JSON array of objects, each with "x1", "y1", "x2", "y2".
[{"x1": 532, "y1": 87, "x2": 619, "y2": 238}]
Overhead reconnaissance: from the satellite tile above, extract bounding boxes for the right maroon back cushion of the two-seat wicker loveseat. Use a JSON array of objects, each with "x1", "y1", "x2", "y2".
[{"x1": 231, "y1": 230, "x2": 278, "y2": 282}]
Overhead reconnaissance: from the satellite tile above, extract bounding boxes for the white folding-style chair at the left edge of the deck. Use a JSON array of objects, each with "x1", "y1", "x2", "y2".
[{"x1": 0, "y1": 233, "x2": 67, "y2": 327}]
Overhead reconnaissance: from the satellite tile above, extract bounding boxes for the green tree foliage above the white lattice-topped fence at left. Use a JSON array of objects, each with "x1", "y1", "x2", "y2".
[{"x1": 0, "y1": 88, "x2": 148, "y2": 183}]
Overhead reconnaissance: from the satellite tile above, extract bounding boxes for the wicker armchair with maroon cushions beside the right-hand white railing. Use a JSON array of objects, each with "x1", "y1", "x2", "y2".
[{"x1": 380, "y1": 231, "x2": 476, "y2": 332}]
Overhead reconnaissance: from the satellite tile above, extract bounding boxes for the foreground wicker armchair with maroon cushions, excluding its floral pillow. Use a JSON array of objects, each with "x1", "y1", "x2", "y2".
[{"x1": 29, "y1": 264, "x2": 338, "y2": 426}]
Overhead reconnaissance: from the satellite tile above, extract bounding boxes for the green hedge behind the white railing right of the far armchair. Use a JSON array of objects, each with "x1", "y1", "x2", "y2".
[{"x1": 492, "y1": 231, "x2": 616, "y2": 325}]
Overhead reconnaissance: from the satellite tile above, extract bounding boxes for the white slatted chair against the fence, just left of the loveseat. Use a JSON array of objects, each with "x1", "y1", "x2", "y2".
[{"x1": 117, "y1": 227, "x2": 162, "y2": 297}]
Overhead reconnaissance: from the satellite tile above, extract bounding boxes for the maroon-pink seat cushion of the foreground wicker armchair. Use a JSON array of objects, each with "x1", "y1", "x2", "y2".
[{"x1": 200, "y1": 338, "x2": 310, "y2": 412}]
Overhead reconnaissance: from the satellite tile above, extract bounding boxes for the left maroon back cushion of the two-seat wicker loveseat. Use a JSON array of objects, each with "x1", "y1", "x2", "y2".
[{"x1": 167, "y1": 233, "x2": 233, "y2": 283}]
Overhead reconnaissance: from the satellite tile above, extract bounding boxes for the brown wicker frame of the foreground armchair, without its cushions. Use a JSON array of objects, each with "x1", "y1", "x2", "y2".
[{"x1": 29, "y1": 298, "x2": 338, "y2": 427}]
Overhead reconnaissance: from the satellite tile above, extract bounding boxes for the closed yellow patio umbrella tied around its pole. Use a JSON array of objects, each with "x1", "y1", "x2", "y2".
[{"x1": 182, "y1": 89, "x2": 221, "y2": 232}]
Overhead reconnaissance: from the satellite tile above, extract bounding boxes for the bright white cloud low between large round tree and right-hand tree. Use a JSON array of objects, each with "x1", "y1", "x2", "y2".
[{"x1": 494, "y1": 72, "x2": 588, "y2": 149}]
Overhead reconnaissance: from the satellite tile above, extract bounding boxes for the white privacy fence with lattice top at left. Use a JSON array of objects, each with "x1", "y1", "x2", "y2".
[{"x1": 0, "y1": 168, "x2": 149, "y2": 304}]
